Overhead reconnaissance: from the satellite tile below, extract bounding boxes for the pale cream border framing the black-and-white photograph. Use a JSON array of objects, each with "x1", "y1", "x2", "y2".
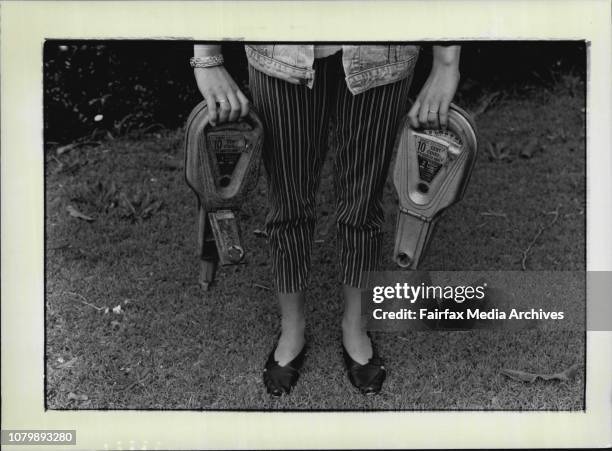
[{"x1": 0, "y1": 0, "x2": 612, "y2": 450}]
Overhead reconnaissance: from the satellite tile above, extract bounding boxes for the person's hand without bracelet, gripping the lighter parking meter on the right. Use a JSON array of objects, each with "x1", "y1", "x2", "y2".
[{"x1": 408, "y1": 65, "x2": 459, "y2": 130}]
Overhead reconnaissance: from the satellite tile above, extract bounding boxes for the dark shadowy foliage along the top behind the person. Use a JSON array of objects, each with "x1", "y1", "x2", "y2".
[{"x1": 44, "y1": 41, "x2": 586, "y2": 146}]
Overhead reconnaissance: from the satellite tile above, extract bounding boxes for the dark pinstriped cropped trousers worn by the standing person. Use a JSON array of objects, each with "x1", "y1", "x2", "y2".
[{"x1": 249, "y1": 53, "x2": 412, "y2": 293}]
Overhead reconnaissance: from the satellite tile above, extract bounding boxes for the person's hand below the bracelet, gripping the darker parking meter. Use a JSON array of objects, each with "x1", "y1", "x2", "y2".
[{"x1": 194, "y1": 66, "x2": 249, "y2": 126}]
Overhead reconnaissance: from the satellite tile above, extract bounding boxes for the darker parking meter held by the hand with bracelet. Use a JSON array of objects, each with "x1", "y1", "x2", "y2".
[{"x1": 185, "y1": 101, "x2": 263, "y2": 289}]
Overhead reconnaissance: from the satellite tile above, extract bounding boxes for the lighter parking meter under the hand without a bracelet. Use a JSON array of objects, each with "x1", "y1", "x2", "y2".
[{"x1": 393, "y1": 104, "x2": 478, "y2": 269}]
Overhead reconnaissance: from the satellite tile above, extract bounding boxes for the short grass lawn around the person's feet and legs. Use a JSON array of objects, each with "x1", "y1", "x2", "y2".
[{"x1": 45, "y1": 76, "x2": 586, "y2": 410}]
